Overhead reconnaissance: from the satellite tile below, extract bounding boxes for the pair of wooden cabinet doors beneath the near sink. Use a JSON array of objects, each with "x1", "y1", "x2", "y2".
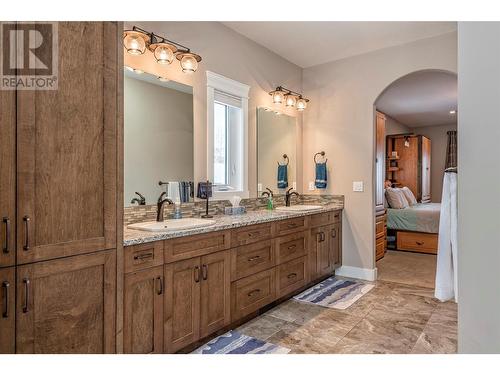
[{"x1": 164, "y1": 250, "x2": 231, "y2": 353}]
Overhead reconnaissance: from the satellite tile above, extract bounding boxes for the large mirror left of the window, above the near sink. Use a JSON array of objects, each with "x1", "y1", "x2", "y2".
[{"x1": 124, "y1": 69, "x2": 194, "y2": 206}]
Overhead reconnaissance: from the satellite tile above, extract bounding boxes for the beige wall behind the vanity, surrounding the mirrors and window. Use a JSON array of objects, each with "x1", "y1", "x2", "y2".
[{"x1": 124, "y1": 22, "x2": 302, "y2": 196}]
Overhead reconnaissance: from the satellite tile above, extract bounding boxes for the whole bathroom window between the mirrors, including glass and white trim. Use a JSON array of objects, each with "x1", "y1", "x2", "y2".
[{"x1": 207, "y1": 72, "x2": 249, "y2": 199}]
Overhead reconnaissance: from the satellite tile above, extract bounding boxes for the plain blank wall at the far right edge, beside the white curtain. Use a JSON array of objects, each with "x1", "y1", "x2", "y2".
[{"x1": 458, "y1": 22, "x2": 500, "y2": 354}]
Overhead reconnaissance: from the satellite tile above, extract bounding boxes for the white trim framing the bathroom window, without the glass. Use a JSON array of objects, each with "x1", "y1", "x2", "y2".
[{"x1": 207, "y1": 71, "x2": 250, "y2": 200}]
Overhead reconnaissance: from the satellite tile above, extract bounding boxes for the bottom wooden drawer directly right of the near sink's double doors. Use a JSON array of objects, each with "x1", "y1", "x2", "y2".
[{"x1": 231, "y1": 268, "x2": 276, "y2": 322}]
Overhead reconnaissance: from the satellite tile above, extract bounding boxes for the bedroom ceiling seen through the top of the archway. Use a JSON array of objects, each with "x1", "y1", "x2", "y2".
[{"x1": 375, "y1": 70, "x2": 458, "y2": 127}]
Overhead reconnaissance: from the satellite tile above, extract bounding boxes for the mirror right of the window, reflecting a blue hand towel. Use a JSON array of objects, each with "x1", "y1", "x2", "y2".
[{"x1": 257, "y1": 108, "x2": 297, "y2": 196}]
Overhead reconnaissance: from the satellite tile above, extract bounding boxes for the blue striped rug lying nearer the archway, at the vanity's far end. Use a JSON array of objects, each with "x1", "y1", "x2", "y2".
[{"x1": 293, "y1": 276, "x2": 375, "y2": 310}]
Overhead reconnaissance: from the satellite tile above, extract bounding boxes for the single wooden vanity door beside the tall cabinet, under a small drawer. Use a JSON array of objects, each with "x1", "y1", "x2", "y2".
[{"x1": 123, "y1": 266, "x2": 165, "y2": 354}]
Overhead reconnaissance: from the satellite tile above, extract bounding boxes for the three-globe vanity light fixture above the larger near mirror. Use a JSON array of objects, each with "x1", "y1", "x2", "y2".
[{"x1": 123, "y1": 26, "x2": 201, "y2": 73}]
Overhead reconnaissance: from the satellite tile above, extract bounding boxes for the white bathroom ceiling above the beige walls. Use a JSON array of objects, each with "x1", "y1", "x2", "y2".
[{"x1": 223, "y1": 21, "x2": 457, "y2": 68}]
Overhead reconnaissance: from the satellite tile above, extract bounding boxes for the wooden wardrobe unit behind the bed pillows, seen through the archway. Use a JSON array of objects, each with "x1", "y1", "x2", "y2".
[{"x1": 386, "y1": 134, "x2": 431, "y2": 203}]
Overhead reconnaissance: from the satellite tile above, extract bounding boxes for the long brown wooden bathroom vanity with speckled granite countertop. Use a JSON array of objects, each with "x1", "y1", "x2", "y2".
[{"x1": 123, "y1": 203, "x2": 343, "y2": 353}]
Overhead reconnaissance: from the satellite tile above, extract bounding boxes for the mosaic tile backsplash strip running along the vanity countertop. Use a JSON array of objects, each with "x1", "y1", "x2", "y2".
[{"x1": 123, "y1": 195, "x2": 344, "y2": 225}]
